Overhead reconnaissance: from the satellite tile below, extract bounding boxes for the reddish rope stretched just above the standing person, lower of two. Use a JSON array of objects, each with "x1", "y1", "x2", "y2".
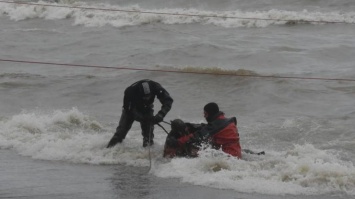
[{"x1": 0, "y1": 58, "x2": 355, "y2": 82}]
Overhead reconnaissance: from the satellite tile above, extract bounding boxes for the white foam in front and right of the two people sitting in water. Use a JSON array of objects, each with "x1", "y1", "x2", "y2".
[{"x1": 154, "y1": 144, "x2": 355, "y2": 195}]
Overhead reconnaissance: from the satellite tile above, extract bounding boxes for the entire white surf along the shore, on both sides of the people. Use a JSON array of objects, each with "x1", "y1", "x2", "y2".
[{"x1": 0, "y1": 108, "x2": 355, "y2": 195}]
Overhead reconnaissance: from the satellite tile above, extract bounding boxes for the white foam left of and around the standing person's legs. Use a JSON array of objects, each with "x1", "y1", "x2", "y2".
[{"x1": 0, "y1": 108, "x2": 168, "y2": 166}]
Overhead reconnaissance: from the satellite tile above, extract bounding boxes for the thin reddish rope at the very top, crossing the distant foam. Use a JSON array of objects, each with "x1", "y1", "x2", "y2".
[{"x1": 0, "y1": 0, "x2": 354, "y2": 24}]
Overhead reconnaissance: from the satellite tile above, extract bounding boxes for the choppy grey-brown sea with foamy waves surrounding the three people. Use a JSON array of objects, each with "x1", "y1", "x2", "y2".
[{"x1": 0, "y1": 1, "x2": 355, "y2": 198}]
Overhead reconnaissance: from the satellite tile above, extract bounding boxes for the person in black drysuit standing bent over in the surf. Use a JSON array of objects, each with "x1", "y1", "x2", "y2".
[{"x1": 107, "y1": 79, "x2": 173, "y2": 148}]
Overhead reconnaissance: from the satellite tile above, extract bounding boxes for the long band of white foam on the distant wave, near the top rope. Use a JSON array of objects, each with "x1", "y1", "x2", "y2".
[{"x1": 0, "y1": 1, "x2": 355, "y2": 28}]
